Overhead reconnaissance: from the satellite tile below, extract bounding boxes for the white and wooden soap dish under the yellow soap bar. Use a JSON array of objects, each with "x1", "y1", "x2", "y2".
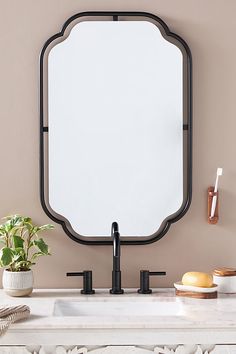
[{"x1": 174, "y1": 281, "x2": 218, "y2": 299}]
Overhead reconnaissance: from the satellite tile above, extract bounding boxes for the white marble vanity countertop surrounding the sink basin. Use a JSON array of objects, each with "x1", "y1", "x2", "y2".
[{"x1": 0, "y1": 289, "x2": 236, "y2": 344}]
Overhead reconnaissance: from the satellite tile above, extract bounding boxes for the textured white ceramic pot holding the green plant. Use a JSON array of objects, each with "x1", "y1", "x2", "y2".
[{"x1": 2, "y1": 269, "x2": 34, "y2": 296}]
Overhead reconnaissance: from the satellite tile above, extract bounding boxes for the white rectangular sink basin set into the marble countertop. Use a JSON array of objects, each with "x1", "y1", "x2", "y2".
[{"x1": 53, "y1": 298, "x2": 181, "y2": 317}]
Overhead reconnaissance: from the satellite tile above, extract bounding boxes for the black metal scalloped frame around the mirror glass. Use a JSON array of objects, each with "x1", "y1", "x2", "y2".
[{"x1": 40, "y1": 11, "x2": 192, "y2": 245}]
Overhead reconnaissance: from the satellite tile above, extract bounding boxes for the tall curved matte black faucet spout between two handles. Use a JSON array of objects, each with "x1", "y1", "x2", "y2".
[{"x1": 110, "y1": 222, "x2": 124, "y2": 294}]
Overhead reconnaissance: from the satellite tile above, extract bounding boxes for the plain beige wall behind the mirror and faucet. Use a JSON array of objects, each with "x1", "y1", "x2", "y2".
[{"x1": 0, "y1": 0, "x2": 236, "y2": 288}]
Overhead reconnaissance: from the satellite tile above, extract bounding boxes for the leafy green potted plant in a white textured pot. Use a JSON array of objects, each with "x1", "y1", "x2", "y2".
[{"x1": 0, "y1": 215, "x2": 54, "y2": 296}]
